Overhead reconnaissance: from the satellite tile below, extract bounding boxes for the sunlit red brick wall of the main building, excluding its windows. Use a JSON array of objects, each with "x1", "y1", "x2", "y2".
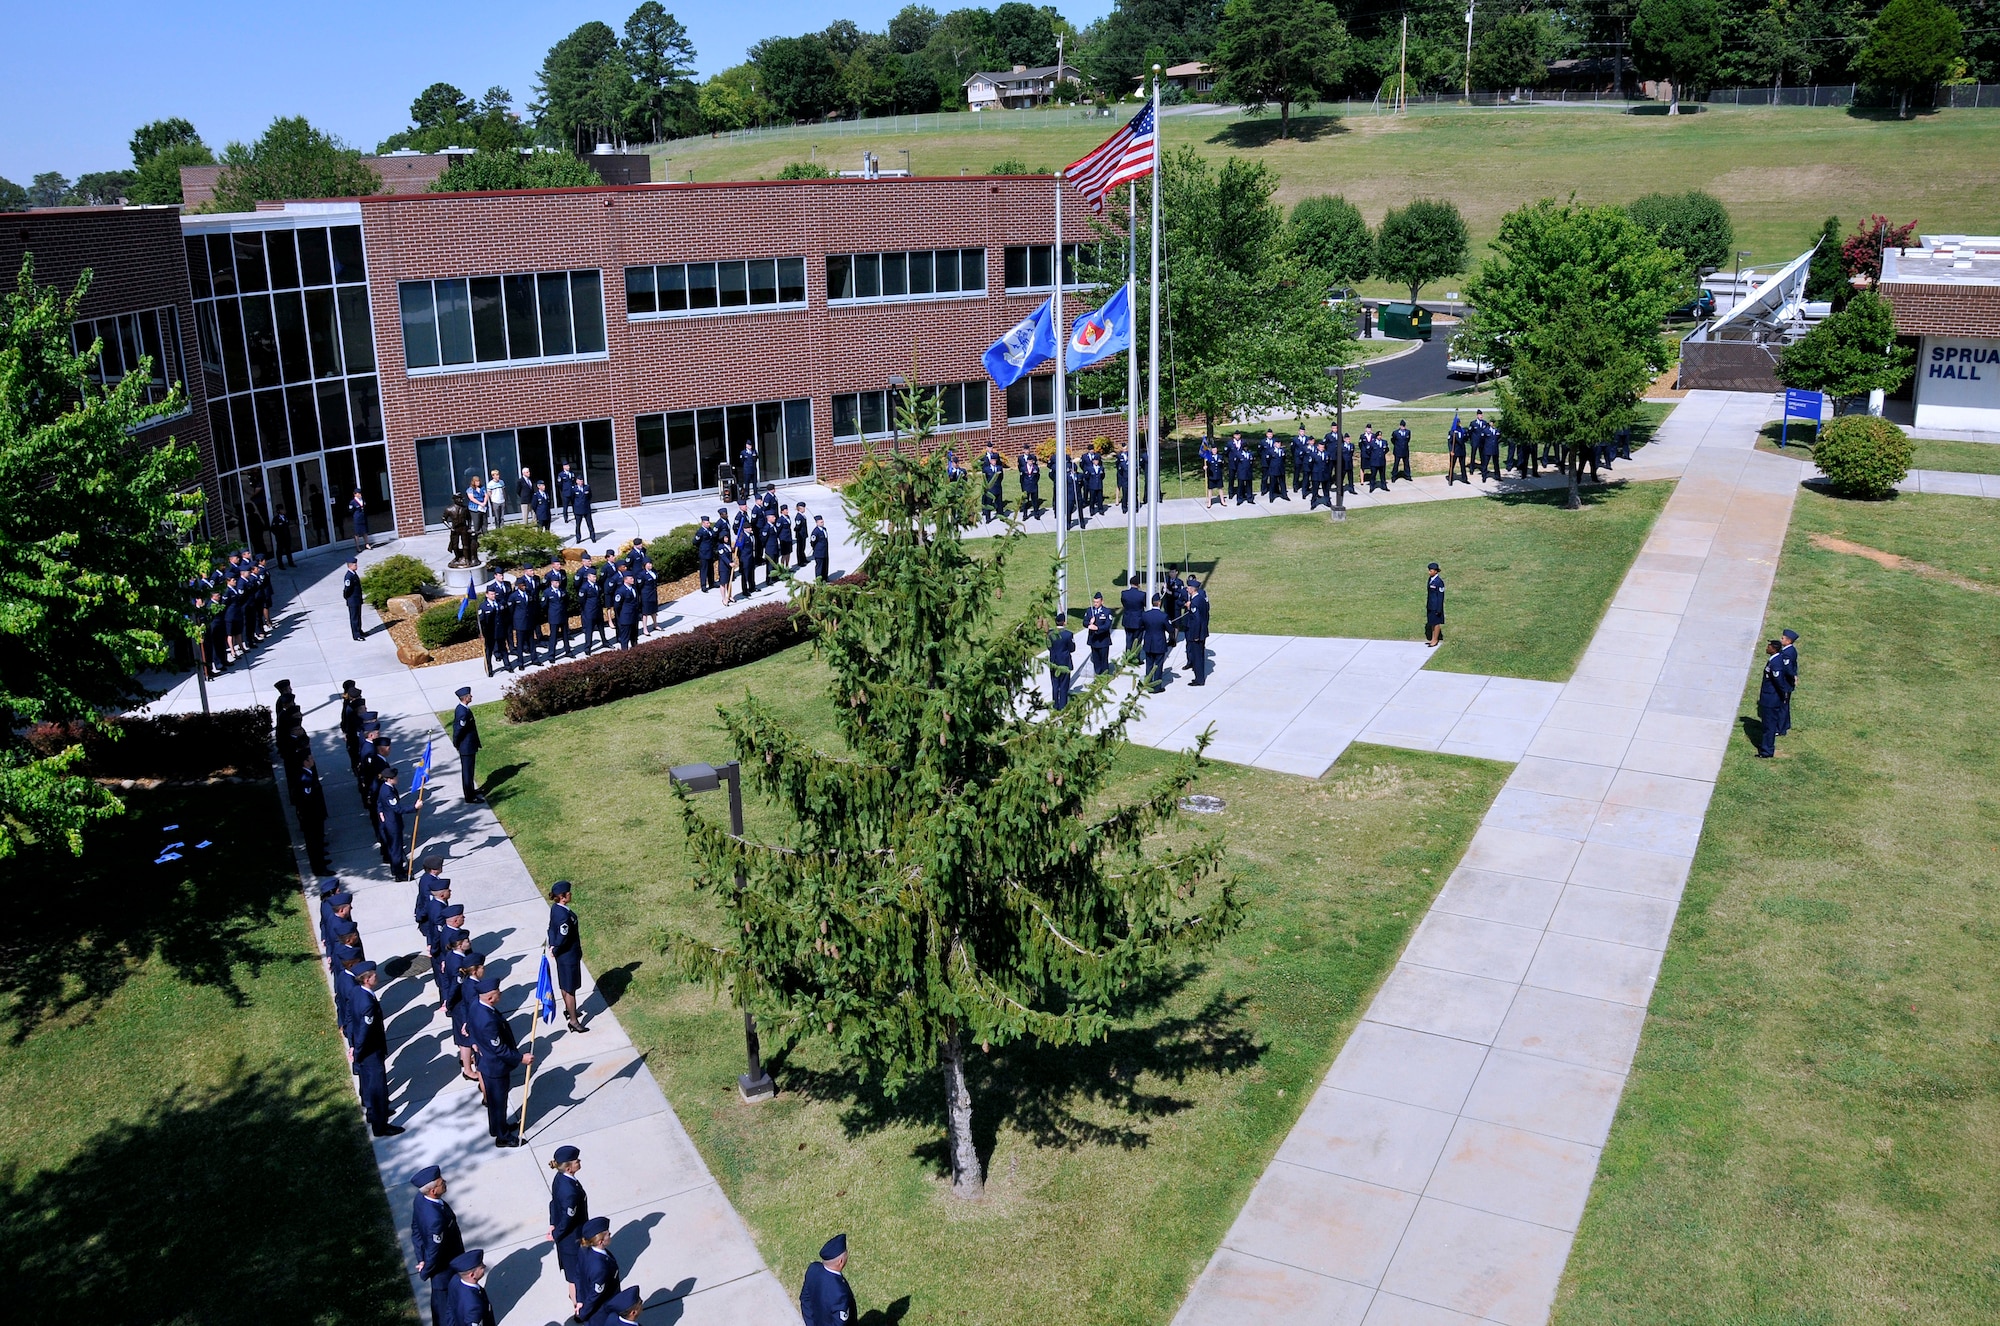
[{"x1": 362, "y1": 176, "x2": 1124, "y2": 534}]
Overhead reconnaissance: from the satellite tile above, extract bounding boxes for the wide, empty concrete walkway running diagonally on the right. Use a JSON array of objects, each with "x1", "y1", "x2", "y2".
[{"x1": 1176, "y1": 392, "x2": 1800, "y2": 1326}]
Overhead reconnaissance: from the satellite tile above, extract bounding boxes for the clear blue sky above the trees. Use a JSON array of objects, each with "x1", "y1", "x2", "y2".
[{"x1": 0, "y1": 0, "x2": 1112, "y2": 184}]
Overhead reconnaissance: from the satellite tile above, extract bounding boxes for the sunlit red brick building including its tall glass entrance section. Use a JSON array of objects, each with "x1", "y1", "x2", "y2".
[{"x1": 180, "y1": 176, "x2": 1120, "y2": 548}]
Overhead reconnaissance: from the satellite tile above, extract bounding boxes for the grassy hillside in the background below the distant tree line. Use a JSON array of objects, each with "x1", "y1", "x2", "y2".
[{"x1": 654, "y1": 108, "x2": 2000, "y2": 280}]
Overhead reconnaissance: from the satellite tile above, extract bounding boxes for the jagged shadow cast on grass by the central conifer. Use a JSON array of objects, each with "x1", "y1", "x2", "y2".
[{"x1": 768, "y1": 968, "x2": 1264, "y2": 1172}]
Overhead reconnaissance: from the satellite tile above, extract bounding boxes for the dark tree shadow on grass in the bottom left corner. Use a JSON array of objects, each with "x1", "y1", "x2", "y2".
[{"x1": 0, "y1": 1064, "x2": 410, "y2": 1326}]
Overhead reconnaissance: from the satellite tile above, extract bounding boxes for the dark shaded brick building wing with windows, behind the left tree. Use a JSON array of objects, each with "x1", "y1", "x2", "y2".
[{"x1": 0, "y1": 206, "x2": 218, "y2": 508}]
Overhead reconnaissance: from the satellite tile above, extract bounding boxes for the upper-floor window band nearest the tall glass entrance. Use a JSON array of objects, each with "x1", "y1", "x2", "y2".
[{"x1": 396, "y1": 270, "x2": 604, "y2": 374}]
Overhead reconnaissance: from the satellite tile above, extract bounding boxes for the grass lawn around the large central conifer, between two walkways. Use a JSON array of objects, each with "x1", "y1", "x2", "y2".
[{"x1": 482, "y1": 650, "x2": 1506, "y2": 1326}]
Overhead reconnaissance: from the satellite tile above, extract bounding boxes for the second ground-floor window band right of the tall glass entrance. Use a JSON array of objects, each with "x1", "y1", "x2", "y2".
[{"x1": 634, "y1": 398, "x2": 812, "y2": 498}]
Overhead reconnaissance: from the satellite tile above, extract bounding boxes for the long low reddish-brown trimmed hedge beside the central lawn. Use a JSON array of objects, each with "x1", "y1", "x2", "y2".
[{"x1": 506, "y1": 576, "x2": 856, "y2": 722}]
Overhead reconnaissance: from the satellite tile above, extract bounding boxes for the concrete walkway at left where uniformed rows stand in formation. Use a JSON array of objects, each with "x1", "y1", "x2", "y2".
[{"x1": 152, "y1": 488, "x2": 872, "y2": 1326}]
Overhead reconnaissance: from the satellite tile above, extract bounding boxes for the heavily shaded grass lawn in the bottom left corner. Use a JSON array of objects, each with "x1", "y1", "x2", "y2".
[{"x1": 0, "y1": 784, "x2": 416, "y2": 1326}]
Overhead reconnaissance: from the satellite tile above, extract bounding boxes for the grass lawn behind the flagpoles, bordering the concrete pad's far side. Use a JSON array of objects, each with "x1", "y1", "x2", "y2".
[{"x1": 1008, "y1": 482, "x2": 1672, "y2": 682}]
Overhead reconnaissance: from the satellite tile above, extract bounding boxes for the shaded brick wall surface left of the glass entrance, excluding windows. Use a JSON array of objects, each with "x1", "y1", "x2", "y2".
[{"x1": 0, "y1": 208, "x2": 220, "y2": 520}]
